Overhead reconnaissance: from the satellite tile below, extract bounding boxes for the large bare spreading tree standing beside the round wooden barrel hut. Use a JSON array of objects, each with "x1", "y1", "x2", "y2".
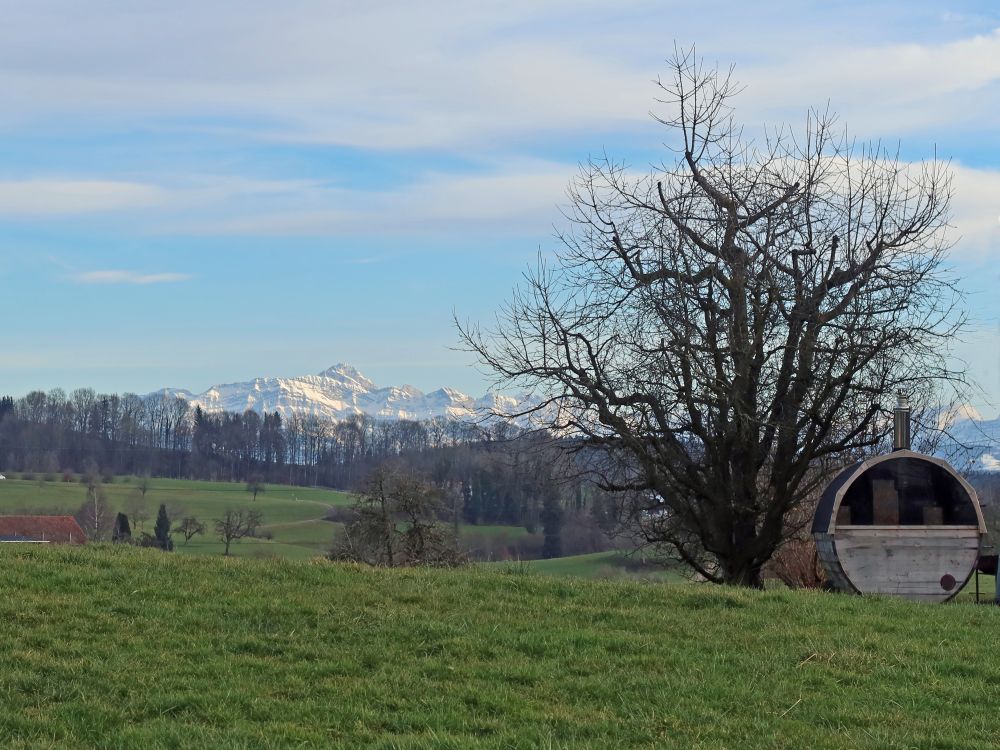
[{"x1": 459, "y1": 51, "x2": 964, "y2": 586}]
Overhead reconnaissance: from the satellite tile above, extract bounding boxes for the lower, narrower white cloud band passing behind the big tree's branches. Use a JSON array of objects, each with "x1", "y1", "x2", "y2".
[{"x1": 0, "y1": 160, "x2": 1000, "y2": 254}]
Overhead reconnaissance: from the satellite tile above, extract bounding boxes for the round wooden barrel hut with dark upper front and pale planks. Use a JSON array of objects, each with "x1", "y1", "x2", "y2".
[{"x1": 812, "y1": 450, "x2": 986, "y2": 602}]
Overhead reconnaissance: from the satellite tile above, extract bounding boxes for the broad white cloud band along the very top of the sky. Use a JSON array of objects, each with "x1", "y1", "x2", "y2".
[{"x1": 0, "y1": 0, "x2": 1000, "y2": 149}]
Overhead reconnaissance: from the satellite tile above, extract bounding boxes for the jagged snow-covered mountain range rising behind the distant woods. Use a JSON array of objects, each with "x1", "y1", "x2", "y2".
[{"x1": 155, "y1": 364, "x2": 527, "y2": 420}]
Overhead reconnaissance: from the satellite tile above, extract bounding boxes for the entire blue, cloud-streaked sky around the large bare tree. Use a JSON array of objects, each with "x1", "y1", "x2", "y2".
[{"x1": 0, "y1": 0, "x2": 1000, "y2": 416}]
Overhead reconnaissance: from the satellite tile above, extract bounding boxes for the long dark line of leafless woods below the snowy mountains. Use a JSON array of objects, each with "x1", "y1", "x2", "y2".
[{"x1": 0, "y1": 389, "x2": 614, "y2": 557}]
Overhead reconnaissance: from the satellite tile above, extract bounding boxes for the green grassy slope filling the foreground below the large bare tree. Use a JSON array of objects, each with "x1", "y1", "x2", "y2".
[{"x1": 0, "y1": 545, "x2": 1000, "y2": 750}]
